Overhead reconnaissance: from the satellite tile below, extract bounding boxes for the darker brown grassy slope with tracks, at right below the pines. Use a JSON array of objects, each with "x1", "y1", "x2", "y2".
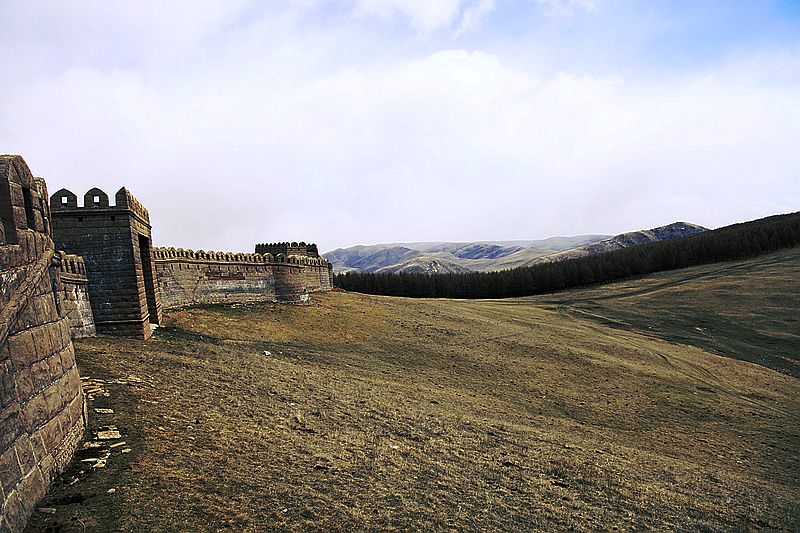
[{"x1": 532, "y1": 247, "x2": 800, "y2": 378}]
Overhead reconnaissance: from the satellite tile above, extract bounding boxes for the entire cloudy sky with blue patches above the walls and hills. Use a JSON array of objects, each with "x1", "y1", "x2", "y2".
[{"x1": 0, "y1": 0, "x2": 800, "y2": 251}]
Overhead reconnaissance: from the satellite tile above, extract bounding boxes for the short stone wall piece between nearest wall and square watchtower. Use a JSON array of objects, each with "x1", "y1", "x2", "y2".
[{"x1": 56, "y1": 252, "x2": 97, "y2": 339}]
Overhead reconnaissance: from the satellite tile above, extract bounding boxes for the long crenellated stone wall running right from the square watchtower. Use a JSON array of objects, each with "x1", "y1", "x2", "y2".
[{"x1": 153, "y1": 248, "x2": 333, "y2": 308}]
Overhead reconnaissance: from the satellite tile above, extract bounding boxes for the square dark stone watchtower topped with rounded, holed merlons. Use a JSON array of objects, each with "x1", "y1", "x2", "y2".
[{"x1": 50, "y1": 187, "x2": 161, "y2": 339}]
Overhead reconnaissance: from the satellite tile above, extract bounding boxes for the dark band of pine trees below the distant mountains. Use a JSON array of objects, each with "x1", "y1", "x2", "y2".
[{"x1": 334, "y1": 212, "x2": 800, "y2": 298}]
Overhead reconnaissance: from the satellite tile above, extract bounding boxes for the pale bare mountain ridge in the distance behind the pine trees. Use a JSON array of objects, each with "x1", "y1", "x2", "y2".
[{"x1": 323, "y1": 222, "x2": 705, "y2": 274}]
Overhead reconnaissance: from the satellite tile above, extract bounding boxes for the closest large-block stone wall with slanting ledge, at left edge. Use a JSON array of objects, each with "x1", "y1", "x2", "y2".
[{"x1": 0, "y1": 156, "x2": 84, "y2": 532}]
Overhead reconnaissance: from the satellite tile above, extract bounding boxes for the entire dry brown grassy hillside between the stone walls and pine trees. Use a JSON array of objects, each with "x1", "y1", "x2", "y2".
[{"x1": 29, "y1": 249, "x2": 800, "y2": 531}]
